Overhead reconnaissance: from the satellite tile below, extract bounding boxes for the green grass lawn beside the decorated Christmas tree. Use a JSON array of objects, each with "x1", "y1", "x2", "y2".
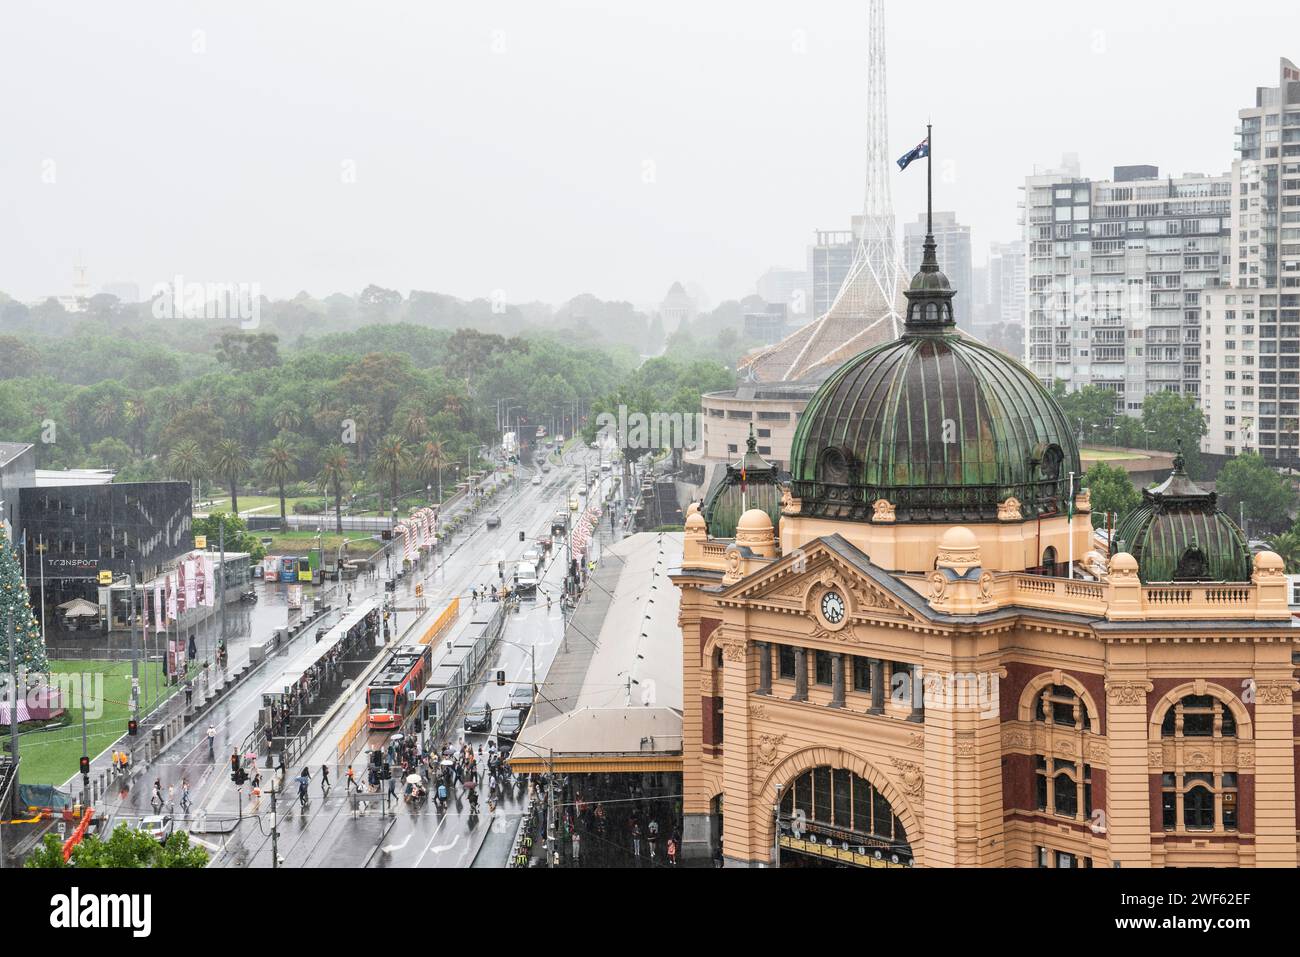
[{"x1": 18, "y1": 661, "x2": 177, "y2": 784}]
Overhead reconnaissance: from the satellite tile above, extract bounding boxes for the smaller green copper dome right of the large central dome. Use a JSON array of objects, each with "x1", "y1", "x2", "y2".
[{"x1": 1115, "y1": 454, "x2": 1251, "y2": 583}]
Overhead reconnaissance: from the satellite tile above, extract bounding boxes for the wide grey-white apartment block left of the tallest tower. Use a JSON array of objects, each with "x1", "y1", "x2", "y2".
[{"x1": 1023, "y1": 165, "x2": 1232, "y2": 415}]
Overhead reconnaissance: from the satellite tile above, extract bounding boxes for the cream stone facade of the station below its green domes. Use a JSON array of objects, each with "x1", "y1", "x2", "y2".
[{"x1": 675, "y1": 512, "x2": 1297, "y2": 867}]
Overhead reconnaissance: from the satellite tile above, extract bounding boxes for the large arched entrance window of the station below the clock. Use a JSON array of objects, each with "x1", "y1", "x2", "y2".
[{"x1": 774, "y1": 765, "x2": 913, "y2": 867}]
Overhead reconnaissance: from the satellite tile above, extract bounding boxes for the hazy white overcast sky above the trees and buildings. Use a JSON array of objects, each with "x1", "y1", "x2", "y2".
[{"x1": 0, "y1": 0, "x2": 1300, "y2": 304}]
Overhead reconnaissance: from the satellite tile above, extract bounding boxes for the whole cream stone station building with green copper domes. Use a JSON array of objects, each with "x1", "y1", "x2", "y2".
[{"x1": 672, "y1": 222, "x2": 1300, "y2": 869}]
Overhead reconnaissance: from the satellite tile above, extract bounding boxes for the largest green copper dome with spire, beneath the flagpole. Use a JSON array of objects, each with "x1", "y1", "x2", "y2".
[{"x1": 790, "y1": 227, "x2": 1082, "y2": 523}]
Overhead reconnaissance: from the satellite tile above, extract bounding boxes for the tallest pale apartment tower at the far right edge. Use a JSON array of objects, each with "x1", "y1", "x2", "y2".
[{"x1": 1201, "y1": 60, "x2": 1300, "y2": 465}]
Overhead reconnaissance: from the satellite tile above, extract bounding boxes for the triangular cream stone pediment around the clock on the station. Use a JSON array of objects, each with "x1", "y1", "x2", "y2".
[{"x1": 720, "y1": 540, "x2": 920, "y2": 624}]
